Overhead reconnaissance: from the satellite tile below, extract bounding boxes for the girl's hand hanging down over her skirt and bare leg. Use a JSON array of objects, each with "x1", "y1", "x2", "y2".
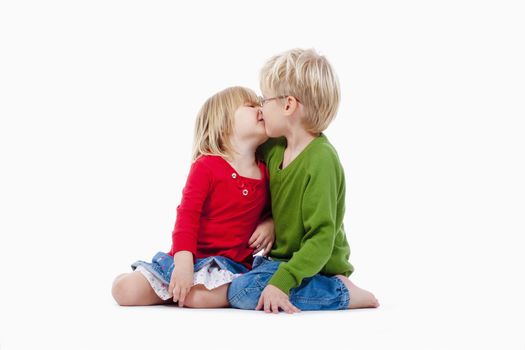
[{"x1": 168, "y1": 250, "x2": 193, "y2": 307}]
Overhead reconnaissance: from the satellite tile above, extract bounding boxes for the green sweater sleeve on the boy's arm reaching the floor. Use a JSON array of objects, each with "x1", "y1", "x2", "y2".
[{"x1": 269, "y1": 157, "x2": 339, "y2": 294}]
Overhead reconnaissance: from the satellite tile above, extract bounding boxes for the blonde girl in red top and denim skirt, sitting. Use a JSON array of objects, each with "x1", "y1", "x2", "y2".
[{"x1": 112, "y1": 87, "x2": 275, "y2": 307}]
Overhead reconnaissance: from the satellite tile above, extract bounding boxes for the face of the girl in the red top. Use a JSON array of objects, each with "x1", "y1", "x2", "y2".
[{"x1": 233, "y1": 102, "x2": 268, "y2": 145}]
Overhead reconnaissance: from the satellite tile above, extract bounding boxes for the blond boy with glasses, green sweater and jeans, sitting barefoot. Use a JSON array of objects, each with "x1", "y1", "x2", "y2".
[{"x1": 228, "y1": 49, "x2": 379, "y2": 313}]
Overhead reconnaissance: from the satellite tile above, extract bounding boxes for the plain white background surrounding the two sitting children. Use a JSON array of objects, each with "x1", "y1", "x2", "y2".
[{"x1": 0, "y1": 0, "x2": 525, "y2": 350}]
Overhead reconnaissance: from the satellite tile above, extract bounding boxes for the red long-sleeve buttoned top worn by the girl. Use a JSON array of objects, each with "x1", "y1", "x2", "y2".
[{"x1": 169, "y1": 156, "x2": 270, "y2": 268}]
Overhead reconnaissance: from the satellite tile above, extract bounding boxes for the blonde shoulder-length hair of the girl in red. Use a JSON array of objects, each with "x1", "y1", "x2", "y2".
[{"x1": 192, "y1": 86, "x2": 259, "y2": 161}]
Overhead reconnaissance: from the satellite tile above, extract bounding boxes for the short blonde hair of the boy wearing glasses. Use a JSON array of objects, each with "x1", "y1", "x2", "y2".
[{"x1": 260, "y1": 49, "x2": 341, "y2": 133}]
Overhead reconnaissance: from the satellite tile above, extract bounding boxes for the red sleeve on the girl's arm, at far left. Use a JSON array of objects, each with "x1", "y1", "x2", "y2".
[{"x1": 171, "y1": 159, "x2": 212, "y2": 256}]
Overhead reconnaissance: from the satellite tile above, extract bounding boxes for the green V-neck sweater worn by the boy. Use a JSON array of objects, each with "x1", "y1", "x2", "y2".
[{"x1": 258, "y1": 134, "x2": 354, "y2": 294}]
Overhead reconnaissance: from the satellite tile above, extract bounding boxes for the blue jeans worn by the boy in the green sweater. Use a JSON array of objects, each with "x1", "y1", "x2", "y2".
[{"x1": 228, "y1": 256, "x2": 350, "y2": 311}]
